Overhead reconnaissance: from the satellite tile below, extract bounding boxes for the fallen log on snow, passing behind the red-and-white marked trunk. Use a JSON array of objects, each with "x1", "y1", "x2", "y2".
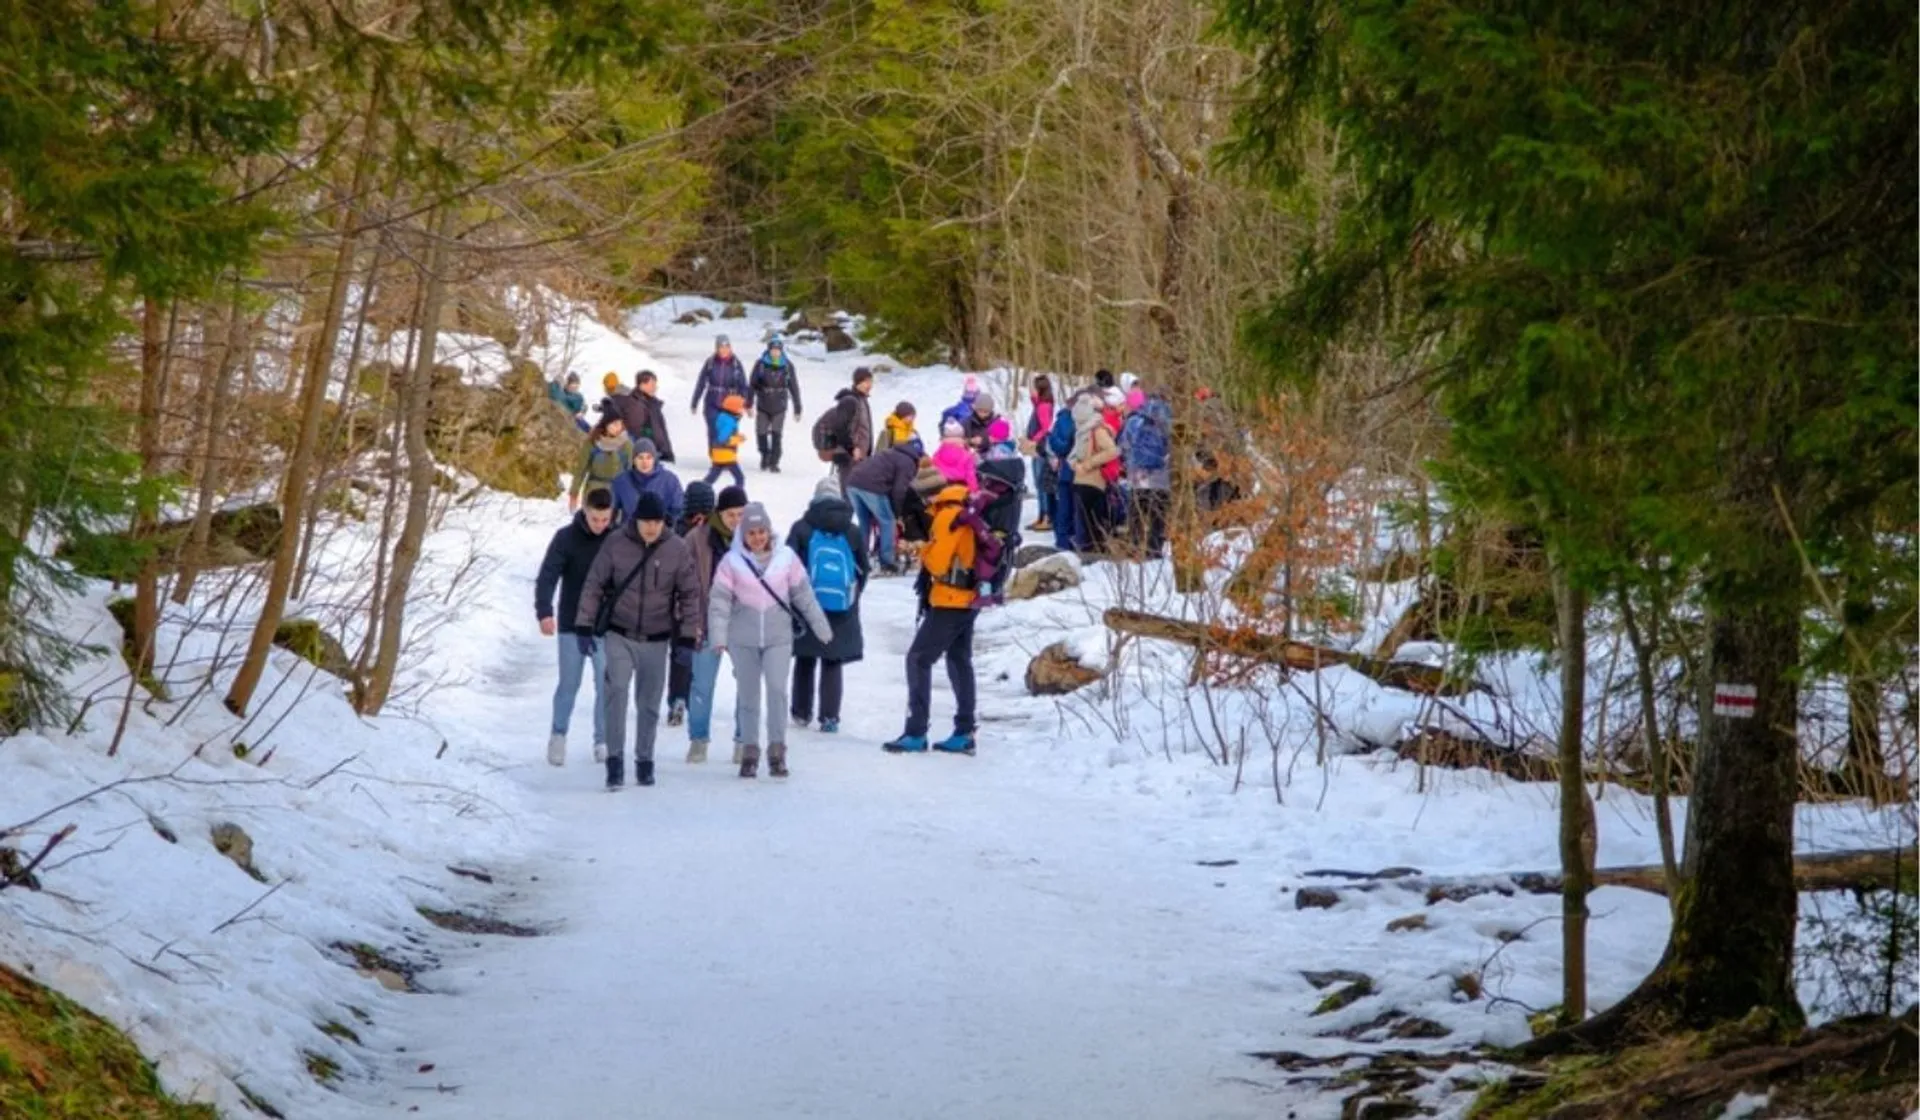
[{"x1": 1304, "y1": 847, "x2": 1920, "y2": 905}]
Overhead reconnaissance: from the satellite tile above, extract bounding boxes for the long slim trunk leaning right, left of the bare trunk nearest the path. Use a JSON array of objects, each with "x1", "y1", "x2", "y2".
[{"x1": 227, "y1": 85, "x2": 382, "y2": 715}]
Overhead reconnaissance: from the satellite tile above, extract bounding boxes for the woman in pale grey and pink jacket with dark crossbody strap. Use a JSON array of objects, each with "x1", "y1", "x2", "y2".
[{"x1": 707, "y1": 501, "x2": 833, "y2": 778}]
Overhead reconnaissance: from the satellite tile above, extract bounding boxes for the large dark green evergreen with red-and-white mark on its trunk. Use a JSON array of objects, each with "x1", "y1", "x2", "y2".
[{"x1": 1223, "y1": 0, "x2": 1920, "y2": 1037}]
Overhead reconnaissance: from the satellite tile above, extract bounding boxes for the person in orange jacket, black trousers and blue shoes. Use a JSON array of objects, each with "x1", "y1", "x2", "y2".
[{"x1": 883, "y1": 482, "x2": 1000, "y2": 755}]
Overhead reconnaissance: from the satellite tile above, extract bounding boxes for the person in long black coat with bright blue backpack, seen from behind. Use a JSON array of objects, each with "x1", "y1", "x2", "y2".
[{"x1": 787, "y1": 478, "x2": 868, "y2": 736}]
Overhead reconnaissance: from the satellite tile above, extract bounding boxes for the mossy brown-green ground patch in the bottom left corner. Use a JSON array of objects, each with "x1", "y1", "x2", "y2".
[{"x1": 0, "y1": 966, "x2": 219, "y2": 1120}]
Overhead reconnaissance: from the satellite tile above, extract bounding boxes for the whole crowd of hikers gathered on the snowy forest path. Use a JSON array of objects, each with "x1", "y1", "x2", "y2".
[{"x1": 534, "y1": 334, "x2": 1198, "y2": 790}]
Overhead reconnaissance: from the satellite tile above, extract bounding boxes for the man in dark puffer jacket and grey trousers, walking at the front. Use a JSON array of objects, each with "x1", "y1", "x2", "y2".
[{"x1": 576, "y1": 492, "x2": 701, "y2": 791}]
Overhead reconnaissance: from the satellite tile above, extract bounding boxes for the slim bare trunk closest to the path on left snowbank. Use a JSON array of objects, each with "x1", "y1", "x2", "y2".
[{"x1": 359, "y1": 207, "x2": 453, "y2": 715}]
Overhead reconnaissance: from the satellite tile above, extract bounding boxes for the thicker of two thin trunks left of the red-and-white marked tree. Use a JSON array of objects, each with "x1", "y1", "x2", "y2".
[{"x1": 1553, "y1": 563, "x2": 1594, "y2": 1024}]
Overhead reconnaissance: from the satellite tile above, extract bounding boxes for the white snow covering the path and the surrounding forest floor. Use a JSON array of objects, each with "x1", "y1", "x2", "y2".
[{"x1": 0, "y1": 298, "x2": 1905, "y2": 1120}]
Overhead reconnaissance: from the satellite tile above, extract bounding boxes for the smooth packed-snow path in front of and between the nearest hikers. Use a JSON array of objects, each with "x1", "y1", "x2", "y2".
[{"x1": 387, "y1": 491, "x2": 1271, "y2": 1118}]
